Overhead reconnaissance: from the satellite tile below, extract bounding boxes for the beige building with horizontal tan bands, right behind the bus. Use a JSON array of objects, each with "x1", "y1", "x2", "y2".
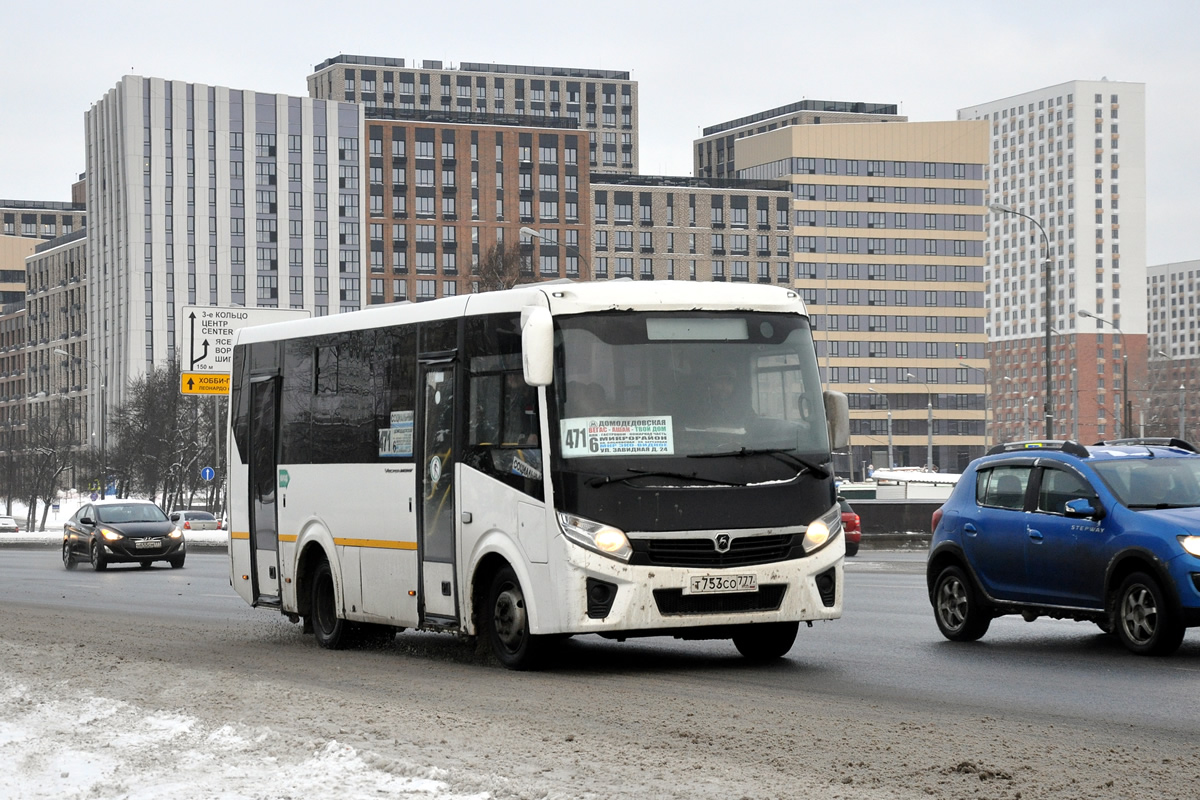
[{"x1": 697, "y1": 115, "x2": 988, "y2": 476}]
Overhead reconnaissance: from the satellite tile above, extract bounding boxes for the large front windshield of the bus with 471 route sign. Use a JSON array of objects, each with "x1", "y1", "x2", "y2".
[{"x1": 556, "y1": 312, "x2": 829, "y2": 480}]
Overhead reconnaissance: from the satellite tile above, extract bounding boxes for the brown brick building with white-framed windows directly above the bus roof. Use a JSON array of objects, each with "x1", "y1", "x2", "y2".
[{"x1": 364, "y1": 117, "x2": 592, "y2": 305}]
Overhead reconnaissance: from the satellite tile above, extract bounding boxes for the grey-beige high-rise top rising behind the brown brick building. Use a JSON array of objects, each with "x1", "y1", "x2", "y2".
[{"x1": 308, "y1": 55, "x2": 637, "y2": 174}]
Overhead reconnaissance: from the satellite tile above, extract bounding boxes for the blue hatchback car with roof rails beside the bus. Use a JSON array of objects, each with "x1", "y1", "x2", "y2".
[{"x1": 926, "y1": 439, "x2": 1200, "y2": 655}]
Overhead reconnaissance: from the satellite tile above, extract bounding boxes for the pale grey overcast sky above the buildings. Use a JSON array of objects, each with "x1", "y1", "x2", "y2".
[{"x1": 0, "y1": 0, "x2": 1200, "y2": 264}]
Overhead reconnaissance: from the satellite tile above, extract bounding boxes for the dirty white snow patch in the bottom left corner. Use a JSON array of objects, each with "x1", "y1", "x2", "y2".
[{"x1": 0, "y1": 675, "x2": 491, "y2": 800}]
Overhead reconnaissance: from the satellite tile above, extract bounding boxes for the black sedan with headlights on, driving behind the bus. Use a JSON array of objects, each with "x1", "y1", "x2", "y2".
[{"x1": 62, "y1": 500, "x2": 187, "y2": 571}]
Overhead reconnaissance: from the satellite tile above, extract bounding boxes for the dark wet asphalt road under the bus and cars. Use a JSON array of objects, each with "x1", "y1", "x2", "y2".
[{"x1": 0, "y1": 549, "x2": 1200, "y2": 734}]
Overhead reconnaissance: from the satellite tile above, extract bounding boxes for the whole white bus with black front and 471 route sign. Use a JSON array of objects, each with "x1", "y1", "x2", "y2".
[{"x1": 228, "y1": 281, "x2": 848, "y2": 669}]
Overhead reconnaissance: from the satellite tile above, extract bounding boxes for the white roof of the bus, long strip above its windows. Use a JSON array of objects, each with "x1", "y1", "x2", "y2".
[{"x1": 235, "y1": 279, "x2": 808, "y2": 344}]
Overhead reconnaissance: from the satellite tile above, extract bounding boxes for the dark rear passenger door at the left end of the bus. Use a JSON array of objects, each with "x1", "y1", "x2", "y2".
[{"x1": 248, "y1": 375, "x2": 280, "y2": 606}]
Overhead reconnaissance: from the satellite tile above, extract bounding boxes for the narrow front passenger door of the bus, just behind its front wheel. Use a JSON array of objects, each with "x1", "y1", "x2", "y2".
[{"x1": 419, "y1": 361, "x2": 458, "y2": 625}]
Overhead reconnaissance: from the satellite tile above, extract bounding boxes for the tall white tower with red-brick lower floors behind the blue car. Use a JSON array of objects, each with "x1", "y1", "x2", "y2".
[{"x1": 959, "y1": 80, "x2": 1147, "y2": 443}]
